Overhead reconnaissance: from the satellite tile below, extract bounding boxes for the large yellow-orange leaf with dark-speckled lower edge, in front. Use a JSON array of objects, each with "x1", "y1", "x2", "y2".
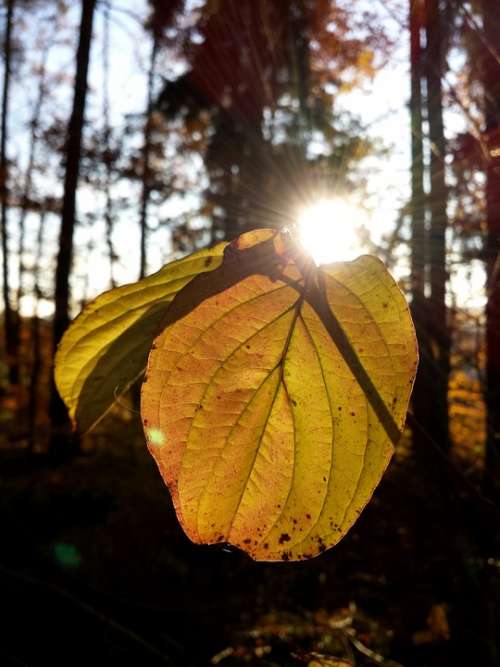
[{"x1": 141, "y1": 231, "x2": 417, "y2": 560}]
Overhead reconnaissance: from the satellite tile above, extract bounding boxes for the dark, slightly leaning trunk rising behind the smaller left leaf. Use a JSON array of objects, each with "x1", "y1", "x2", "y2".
[{"x1": 50, "y1": 0, "x2": 96, "y2": 456}]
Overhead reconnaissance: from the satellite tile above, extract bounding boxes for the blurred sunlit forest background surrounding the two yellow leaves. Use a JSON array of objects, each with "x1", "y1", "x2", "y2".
[{"x1": 0, "y1": 0, "x2": 500, "y2": 666}]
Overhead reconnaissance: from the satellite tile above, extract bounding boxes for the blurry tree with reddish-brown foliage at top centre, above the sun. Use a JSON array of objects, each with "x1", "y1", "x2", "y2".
[{"x1": 159, "y1": 0, "x2": 384, "y2": 245}]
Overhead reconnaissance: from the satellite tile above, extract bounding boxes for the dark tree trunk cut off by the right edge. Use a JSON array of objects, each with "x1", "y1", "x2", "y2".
[{"x1": 483, "y1": 0, "x2": 500, "y2": 502}]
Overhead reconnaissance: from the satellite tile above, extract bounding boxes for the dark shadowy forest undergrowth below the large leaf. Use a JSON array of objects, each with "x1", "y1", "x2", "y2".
[{"x1": 0, "y1": 419, "x2": 500, "y2": 667}]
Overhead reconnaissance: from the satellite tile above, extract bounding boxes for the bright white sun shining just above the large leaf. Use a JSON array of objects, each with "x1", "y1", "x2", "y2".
[{"x1": 298, "y1": 198, "x2": 364, "y2": 264}]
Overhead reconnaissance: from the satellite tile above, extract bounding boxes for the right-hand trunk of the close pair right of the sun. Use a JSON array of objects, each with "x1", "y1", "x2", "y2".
[{"x1": 425, "y1": 0, "x2": 450, "y2": 449}]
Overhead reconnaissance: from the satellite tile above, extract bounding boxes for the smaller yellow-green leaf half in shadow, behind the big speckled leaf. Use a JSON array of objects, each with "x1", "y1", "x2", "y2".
[{"x1": 55, "y1": 243, "x2": 227, "y2": 431}]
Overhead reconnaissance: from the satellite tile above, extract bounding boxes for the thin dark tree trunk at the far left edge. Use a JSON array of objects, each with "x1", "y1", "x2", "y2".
[{"x1": 0, "y1": 0, "x2": 19, "y2": 384}]
